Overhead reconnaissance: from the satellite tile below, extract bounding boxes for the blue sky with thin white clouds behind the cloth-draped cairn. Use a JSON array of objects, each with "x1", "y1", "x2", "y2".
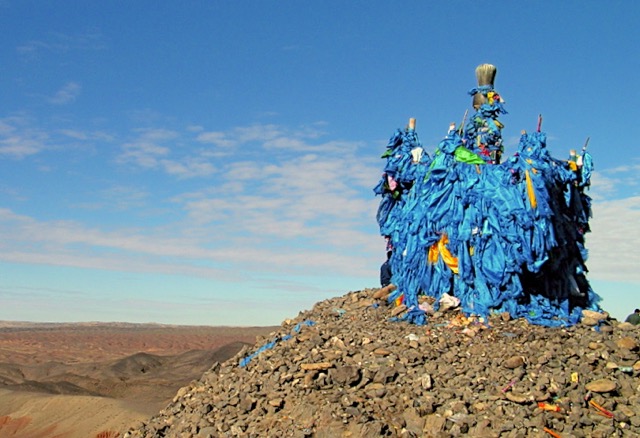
[{"x1": 0, "y1": 0, "x2": 640, "y2": 325}]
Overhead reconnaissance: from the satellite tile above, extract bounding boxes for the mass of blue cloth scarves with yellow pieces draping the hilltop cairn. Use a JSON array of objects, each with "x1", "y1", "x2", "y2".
[{"x1": 374, "y1": 80, "x2": 600, "y2": 326}]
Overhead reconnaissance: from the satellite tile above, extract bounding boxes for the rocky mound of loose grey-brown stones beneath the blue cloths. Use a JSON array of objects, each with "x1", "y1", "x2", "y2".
[{"x1": 123, "y1": 289, "x2": 640, "y2": 438}]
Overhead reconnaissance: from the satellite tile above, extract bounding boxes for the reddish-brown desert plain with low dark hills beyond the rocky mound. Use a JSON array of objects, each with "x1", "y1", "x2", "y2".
[{"x1": 0, "y1": 321, "x2": 276, "y2": 438}]
